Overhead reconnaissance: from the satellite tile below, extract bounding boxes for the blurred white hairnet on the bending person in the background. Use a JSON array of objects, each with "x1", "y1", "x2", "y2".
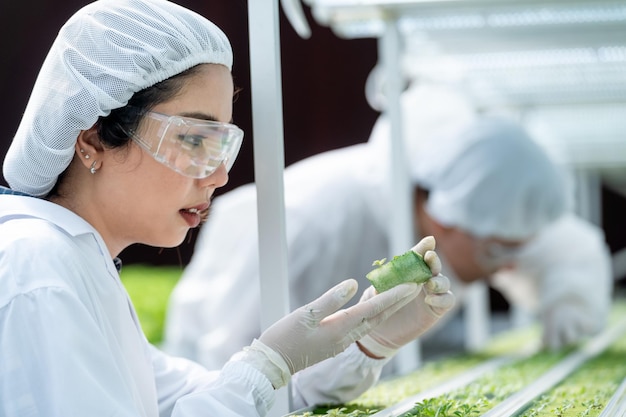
[{"x1": 413, "y1": 117, "x2": 570, "y2": 240}]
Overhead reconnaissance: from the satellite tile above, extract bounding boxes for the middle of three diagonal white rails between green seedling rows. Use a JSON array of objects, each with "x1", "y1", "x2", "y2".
[{"x1": 482, "y1": 320, "x2": 626, "y2": 417}]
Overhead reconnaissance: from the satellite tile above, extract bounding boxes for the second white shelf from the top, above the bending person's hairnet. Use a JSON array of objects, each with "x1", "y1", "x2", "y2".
[{"x1": 403, "y1": 51, "x2": 626, "y2": 107}]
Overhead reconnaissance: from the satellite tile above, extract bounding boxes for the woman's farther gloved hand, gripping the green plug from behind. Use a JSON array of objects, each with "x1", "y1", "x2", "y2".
[{"x1": 359, "y1": 236, "x2": 455, "y2": 358}]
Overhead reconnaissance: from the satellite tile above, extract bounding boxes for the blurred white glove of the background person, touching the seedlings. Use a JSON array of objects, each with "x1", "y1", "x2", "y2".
[{"x1": 542, "y1": 297, "x2": 602, "y2": 350}]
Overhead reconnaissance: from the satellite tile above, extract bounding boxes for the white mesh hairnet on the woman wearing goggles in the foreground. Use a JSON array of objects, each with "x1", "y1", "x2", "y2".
[{"x1": 3, "y1": 0, "x2": 233, "y2": 196}]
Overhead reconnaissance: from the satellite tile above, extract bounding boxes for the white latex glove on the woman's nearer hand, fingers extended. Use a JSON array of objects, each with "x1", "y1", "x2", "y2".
[{"x1": 244, "y1": 279, "x2": 419, "y2": 388}]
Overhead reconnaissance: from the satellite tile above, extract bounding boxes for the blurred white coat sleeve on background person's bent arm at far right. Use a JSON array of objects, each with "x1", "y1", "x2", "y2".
[{"x1": 491, "y1": 214, "x2": 613, "y2": 333}]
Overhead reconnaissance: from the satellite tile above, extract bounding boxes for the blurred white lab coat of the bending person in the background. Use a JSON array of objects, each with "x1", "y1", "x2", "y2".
[{"x1": 164, "y1": 141, "x2": 612, "y2": 374}]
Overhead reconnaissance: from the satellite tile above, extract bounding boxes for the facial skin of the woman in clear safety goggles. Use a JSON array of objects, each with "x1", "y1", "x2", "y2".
[{"x1": 79, "y1": 64, "x2": 233, "y2": 256}]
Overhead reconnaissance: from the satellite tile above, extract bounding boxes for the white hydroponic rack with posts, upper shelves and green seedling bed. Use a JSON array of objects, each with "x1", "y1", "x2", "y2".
[{"x1": 249, "y1": 0, "x2": 626, "y2": 417}]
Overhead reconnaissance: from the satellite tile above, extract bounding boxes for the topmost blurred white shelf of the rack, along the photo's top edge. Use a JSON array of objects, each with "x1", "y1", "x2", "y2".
[{"x1": 307, "y1": 0, "x2": 626, "y2": 45}]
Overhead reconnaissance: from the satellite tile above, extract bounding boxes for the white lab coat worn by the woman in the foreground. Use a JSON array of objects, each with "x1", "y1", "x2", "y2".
[{"x1": 0, "y1": 195, "x2": 386, "y2": 417}]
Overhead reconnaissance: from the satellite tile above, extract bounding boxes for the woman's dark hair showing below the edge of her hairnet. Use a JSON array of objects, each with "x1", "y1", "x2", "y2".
[{"x1": 46, "y1": 65, "x2": 198, "y2": 198}]
